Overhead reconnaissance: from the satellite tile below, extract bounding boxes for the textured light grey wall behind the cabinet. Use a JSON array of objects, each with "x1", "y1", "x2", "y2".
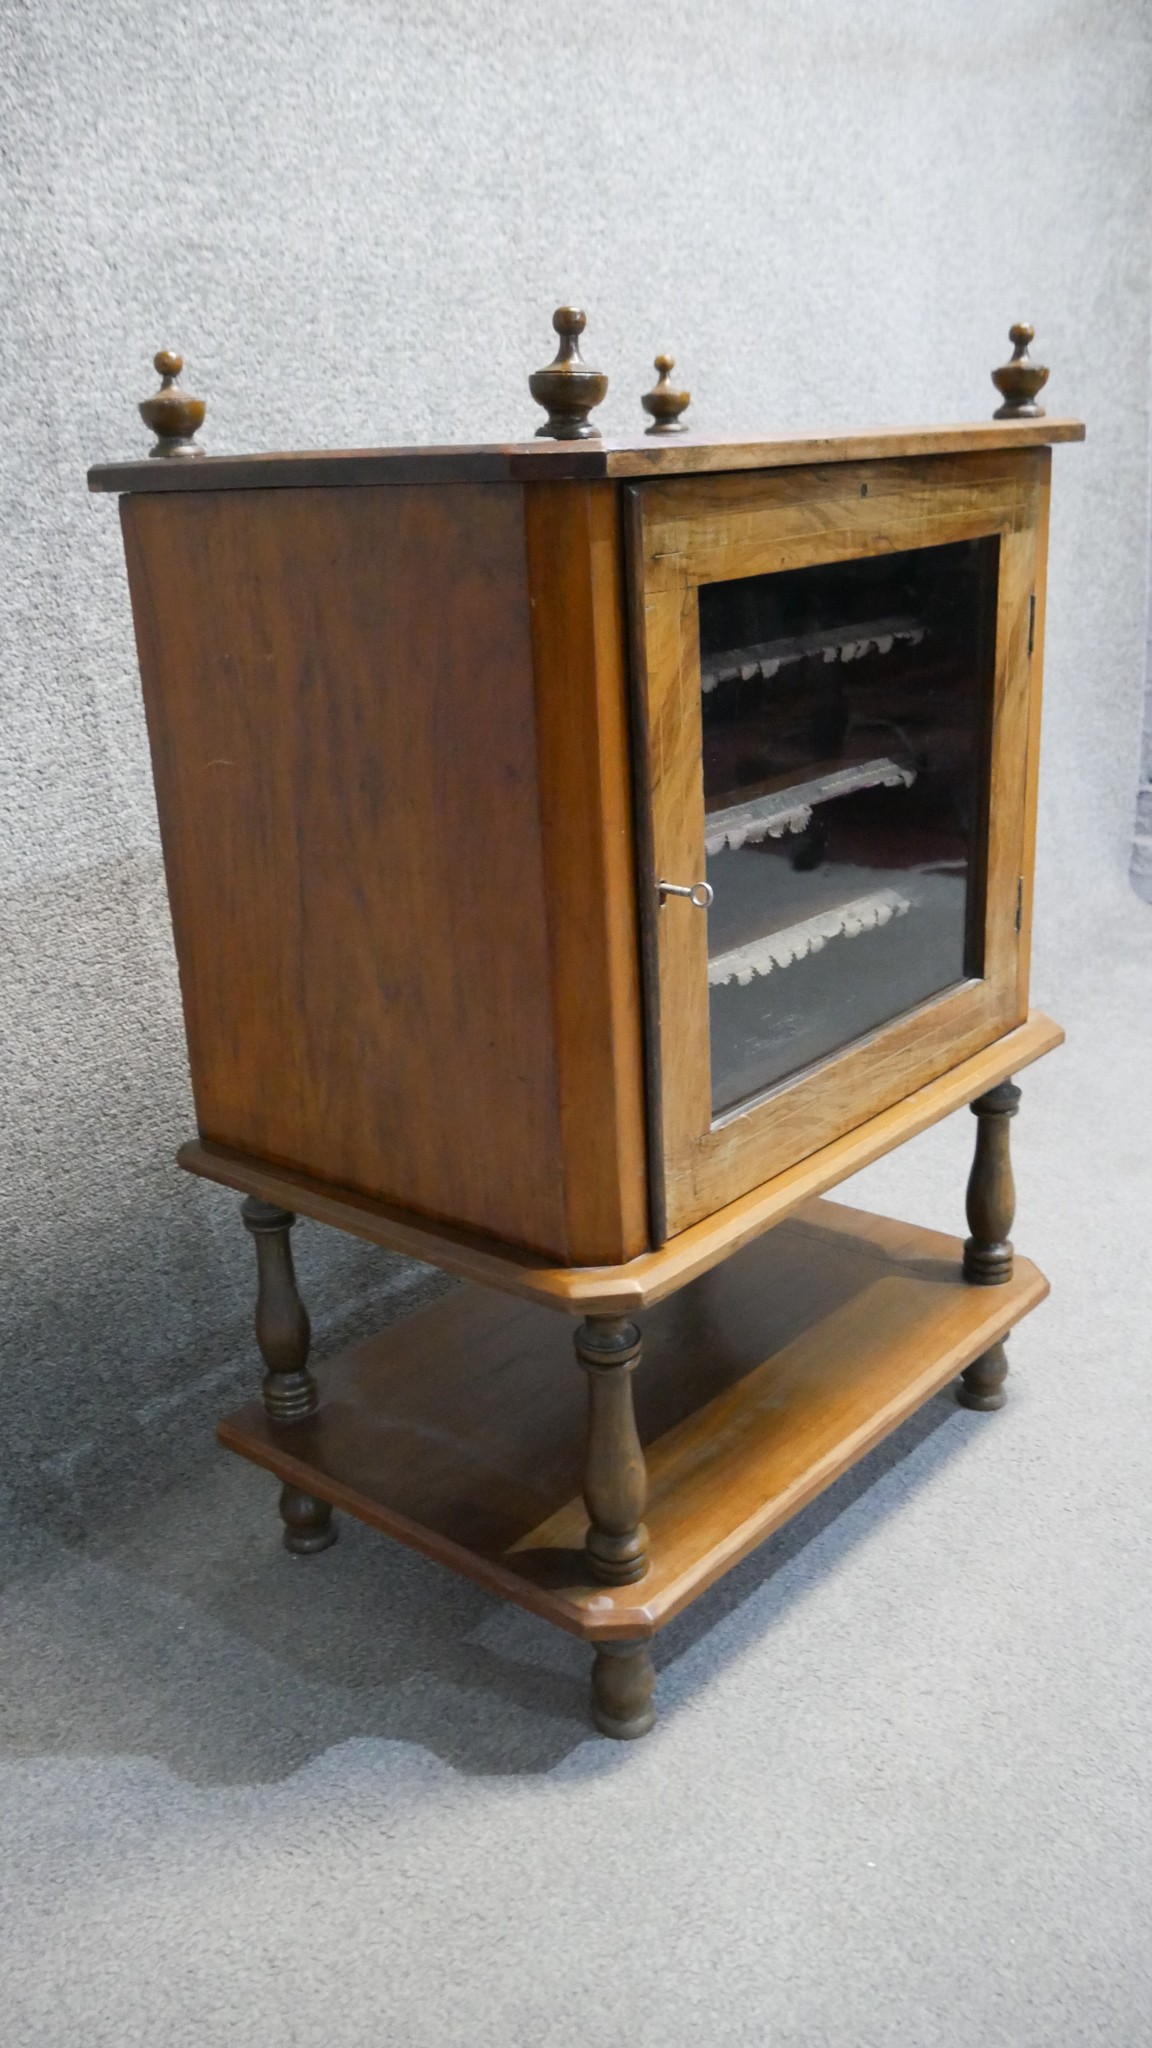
[{"x1": 0, "y1": 0, "x2": 1150, "y2": 1540}]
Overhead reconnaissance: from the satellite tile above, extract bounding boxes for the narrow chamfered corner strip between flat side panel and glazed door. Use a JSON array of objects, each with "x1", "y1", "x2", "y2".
[{"x1": 525, "y1": 483, "x2": 648, "y2": 1266}]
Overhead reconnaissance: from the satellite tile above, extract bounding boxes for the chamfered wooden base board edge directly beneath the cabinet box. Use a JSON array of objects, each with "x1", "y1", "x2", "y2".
[{"x1": 178, "y1": 1012, "x2": 1064, "y2": 1315}]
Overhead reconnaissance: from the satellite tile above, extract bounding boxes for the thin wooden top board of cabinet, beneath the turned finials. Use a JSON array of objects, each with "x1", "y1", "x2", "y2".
[{"x1": 88, "y1": 418, "x2": 1084, "y2": 492}]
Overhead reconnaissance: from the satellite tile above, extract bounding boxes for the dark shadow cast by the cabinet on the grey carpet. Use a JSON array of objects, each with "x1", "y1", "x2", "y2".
[{"x1": 0, "y1": 1389, "x2": 994, "y2": 1784}]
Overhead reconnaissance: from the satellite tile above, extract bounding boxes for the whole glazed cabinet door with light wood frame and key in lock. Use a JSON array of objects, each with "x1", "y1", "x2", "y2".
[{"x1": 627, "y1": 451, "x2": 1050, "y2": 1237}]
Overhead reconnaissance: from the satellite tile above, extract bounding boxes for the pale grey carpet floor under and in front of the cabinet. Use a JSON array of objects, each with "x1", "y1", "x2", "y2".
[{"x1": 0, "y1": 889, "x2": 1152, "y2": 2048}]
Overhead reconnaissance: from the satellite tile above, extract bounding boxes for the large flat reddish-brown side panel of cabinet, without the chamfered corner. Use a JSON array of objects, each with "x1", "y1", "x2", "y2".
[{"x1": 121, "y1": 485, "x2": 568, "y2": 1260}]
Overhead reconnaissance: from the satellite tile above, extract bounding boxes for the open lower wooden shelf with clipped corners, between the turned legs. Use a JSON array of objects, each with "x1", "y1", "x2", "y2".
[{"x1": 217, "y1": 1200, "x2": 1047, "y2": 1640}]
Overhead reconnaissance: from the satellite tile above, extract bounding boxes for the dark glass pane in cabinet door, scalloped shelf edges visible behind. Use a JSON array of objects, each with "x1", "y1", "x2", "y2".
[{"x1": 699, "y1": 537, "x2": 998, "y2": 1114}]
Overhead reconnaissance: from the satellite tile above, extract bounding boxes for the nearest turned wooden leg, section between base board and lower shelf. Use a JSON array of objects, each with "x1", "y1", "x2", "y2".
[{"x1": 576, "y1": 1315, "x2": 648, "y2": 1585}]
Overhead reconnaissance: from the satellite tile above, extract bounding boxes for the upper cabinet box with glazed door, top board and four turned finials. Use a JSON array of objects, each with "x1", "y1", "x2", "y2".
[{"x1": 88, "y1": 307, "x2": 1084, "y2": 1266}]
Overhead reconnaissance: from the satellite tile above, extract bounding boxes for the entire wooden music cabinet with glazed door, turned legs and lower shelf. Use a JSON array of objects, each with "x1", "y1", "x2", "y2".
[{"x1": 90, "y1": 335, "x2": 1082, "y2": 1737}]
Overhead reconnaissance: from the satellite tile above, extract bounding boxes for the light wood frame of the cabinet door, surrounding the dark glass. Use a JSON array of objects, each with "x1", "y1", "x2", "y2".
[{"x1": 631, "y1": 453, "x2": 1039, "y2": 1235}]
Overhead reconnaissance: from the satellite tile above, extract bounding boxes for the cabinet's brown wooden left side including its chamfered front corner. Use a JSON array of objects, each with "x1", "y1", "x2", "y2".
[{"x1": 123, "y1": 483, "x2": 648, "y2": 1264}]
